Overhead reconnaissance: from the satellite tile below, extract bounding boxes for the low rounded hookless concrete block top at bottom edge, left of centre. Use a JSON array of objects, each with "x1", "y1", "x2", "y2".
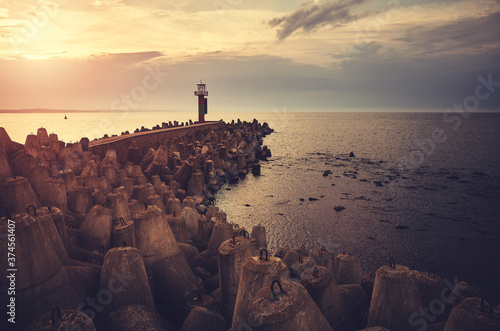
[{"x1": 179, "y1": 307, "x2": 226, "y2": 331}]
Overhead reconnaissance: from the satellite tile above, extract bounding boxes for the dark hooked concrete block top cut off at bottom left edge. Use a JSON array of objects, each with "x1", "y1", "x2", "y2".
[{"x1": 26, "y1": 306, "x2": 96, "y2": 331}]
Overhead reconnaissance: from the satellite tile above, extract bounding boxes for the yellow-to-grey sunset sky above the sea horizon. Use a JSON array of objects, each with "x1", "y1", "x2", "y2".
[{"x1": 0, "y1": 0, "x2": 500, "y2": 111}]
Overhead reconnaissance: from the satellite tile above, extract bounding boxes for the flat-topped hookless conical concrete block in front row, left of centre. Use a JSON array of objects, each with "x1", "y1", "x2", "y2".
[{"x1": 98, "y1": 247, "x2": 155, "y2": 319}]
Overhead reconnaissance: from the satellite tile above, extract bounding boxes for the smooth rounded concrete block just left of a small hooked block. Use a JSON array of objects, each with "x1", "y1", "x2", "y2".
[{"x1": 79, "y1": 205, "x2": 113, "y2": 251}]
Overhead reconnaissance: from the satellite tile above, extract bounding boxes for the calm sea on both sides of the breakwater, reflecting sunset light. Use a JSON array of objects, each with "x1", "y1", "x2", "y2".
[{"x1": 0, "y1": 109, "x2": 500, "y2": 304}]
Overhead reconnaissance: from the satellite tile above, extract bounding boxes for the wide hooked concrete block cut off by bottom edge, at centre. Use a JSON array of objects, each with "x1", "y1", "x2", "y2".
[{"x1": 248, "y1": 281, "x2": 332, "y2": 331}]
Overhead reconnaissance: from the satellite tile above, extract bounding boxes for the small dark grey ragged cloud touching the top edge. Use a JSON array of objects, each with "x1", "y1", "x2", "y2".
[{"x1": 269, "y1": 0, "x2": 370, "y2": 41}]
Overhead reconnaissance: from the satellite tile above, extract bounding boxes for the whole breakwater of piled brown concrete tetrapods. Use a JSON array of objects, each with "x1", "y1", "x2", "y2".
[{"x1": 1, "y1": 121, "x2": 497, "y2": 330}]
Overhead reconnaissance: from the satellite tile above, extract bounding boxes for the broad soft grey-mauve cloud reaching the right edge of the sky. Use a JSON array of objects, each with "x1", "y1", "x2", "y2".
[{"x1": 395, "y1": 11, "x2": 500, "y2": 54}]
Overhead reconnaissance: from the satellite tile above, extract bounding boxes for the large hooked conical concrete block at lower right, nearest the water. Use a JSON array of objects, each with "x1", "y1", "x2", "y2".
[{"x1": 368, "y1": 261, "x2": 422, "y2": 331}]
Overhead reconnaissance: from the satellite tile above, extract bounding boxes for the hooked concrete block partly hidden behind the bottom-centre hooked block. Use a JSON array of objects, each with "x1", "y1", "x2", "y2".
[{"x1": 232, "y1": 249, "x2": 289, "y2": 330}]
